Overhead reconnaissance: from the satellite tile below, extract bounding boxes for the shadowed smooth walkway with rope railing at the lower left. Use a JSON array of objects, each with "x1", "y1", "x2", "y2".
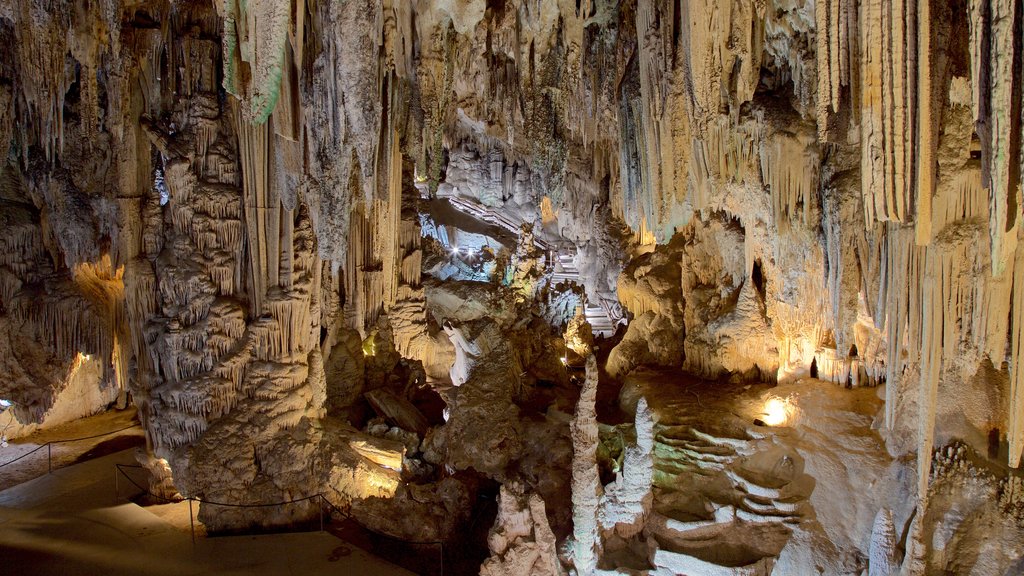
[{"x1": 0, "y1": 450, "x2": 412, "y2": 576}]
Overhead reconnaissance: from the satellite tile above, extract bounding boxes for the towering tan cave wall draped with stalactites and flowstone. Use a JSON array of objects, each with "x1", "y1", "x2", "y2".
[{"x1": 0, "y1": 0, "x2": 1024, "y2": 557}]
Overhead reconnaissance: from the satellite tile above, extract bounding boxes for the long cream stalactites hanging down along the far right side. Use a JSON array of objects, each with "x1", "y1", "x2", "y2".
[{"x1": 802, "y1": 0, "x2": 1024, "y2": 475}]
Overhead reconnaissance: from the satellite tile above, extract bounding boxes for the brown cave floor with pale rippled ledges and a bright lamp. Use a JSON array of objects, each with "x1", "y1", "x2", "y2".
[{"x1": 621, "y1": 371, "x2": 893, "y2": 574}]
